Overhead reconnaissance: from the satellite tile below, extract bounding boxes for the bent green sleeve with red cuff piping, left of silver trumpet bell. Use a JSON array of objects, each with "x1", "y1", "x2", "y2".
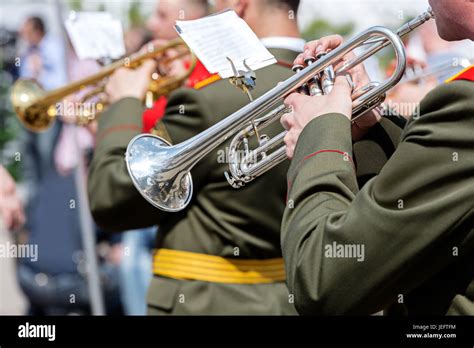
[{"x1": 88, "y1": 98, "x2": 158, "y2": 232}]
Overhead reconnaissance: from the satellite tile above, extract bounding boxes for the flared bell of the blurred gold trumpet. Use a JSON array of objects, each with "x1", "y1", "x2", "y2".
[{"x1": 11, "y1": 80, "x2": 56, "y2": 132}]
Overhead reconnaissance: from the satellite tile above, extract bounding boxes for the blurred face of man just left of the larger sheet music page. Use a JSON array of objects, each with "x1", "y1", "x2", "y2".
[{"x1": 147, "y1": 0, "x2": 186, "y2": 40}]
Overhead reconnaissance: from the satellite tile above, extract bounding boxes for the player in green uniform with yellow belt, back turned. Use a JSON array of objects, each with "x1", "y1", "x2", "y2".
[{"x1": 89, "y1": 0, "x2": 399, "y2": 315}]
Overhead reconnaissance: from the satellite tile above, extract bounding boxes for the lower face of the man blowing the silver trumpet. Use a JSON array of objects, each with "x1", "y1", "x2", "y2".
[{"x1": 429, "y1": 0, "x2": 474, "y2": 41}]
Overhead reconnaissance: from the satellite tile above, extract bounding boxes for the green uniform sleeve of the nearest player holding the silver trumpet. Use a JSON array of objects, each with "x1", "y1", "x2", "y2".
[{"x1": 281, "y1": 82, "x2": 474, "y2": 315}]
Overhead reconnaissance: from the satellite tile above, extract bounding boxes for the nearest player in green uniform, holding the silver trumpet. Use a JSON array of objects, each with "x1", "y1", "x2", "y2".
[{"x1": 281, "y1": 0, "x2": 474, "y2": 315}]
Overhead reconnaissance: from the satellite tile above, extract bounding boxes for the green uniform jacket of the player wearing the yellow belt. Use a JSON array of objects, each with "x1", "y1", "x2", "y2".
[{"x1": 88, "y1": 49, "x2": 400, "y2": 315}]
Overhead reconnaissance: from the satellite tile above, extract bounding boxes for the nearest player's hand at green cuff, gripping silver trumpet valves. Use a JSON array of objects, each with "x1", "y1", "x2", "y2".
[{"x1": 281, "y1": 76, "x2": 352, "y2": 159}]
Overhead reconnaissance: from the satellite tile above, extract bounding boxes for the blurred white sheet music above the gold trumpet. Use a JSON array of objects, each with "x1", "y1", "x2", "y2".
[{"x1": 65, "y1": 12, "x2": 125, "y2": 59}]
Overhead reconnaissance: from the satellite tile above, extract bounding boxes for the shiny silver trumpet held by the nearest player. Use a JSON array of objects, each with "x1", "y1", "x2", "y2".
[{"x1": 125, "y1": 8, "x2": 434, "y2": 212}]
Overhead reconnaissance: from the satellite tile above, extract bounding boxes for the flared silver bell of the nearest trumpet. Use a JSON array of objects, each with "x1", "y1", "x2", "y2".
[{"x1": 125, "y1": 134, "x2": 193, "y2": 212}]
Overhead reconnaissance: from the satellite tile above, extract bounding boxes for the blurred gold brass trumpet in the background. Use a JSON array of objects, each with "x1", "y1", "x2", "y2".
[{"x1": 10, "y1": 39, "x2": 197, "y2": 132}]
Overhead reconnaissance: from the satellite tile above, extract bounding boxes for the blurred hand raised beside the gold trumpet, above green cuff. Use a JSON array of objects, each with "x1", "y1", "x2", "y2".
[{"x1": 105, "y1": 59, "x2": 156, "y2": 103}]
